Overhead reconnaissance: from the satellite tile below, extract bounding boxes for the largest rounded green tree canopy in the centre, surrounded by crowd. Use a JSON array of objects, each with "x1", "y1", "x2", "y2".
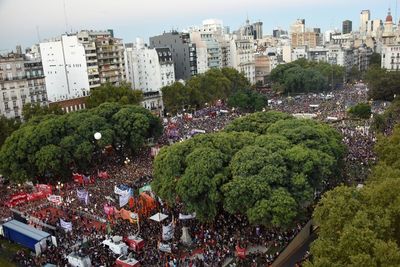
[{"x1": 152, "y1": 112, "x2": 345, "y2": 227}]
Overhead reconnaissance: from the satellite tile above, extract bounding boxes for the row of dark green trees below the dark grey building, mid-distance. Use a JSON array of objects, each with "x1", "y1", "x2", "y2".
[{"x1": 162, "y1": 68, "x2": 266, "y2": 113}]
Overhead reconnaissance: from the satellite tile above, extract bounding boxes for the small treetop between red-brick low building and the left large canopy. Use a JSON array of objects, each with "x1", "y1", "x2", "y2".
[{"x1": 86, "y1": 83, "x2": 143, "y2": 108}]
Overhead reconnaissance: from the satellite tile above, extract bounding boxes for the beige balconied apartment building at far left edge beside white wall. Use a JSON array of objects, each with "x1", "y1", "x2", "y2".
[{"x1": 0, "y1": 49, "x2": 47, "y2": 118}]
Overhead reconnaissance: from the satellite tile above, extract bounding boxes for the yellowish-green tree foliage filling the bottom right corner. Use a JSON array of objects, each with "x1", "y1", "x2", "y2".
[{"x1": 306, "y1": 126, "x2": 400, "y2": 266}]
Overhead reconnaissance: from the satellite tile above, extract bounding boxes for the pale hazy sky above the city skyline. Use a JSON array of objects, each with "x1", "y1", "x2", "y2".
[{"x1": 0, "y1": 0, "x2": 394, "y2": 51}]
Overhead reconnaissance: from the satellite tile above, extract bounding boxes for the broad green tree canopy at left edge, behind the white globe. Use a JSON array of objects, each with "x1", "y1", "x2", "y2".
[{"x1": 0, "y1": 103, "x2": 162, "y2": 181}]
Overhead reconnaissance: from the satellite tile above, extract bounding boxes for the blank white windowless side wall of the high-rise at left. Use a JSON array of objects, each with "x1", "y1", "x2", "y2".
[{"x1": 40, "y1": 35, "x2": 90, "y2": 102}]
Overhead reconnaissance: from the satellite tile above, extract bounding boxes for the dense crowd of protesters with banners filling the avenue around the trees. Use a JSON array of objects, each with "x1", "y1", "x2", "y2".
[{"x1": 0, "y1": 84, "x2": 386, "y2": 266}]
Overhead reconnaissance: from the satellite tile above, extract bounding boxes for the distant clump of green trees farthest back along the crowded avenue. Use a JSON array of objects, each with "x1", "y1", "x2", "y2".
[{"x1": 270, "y1": 59, "x2": 345, "y2": 93}]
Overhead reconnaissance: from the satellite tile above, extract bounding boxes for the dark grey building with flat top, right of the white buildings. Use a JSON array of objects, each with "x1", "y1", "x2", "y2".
[{"x1": 150, "y1": 31, "x2": 197, "y2": 80}]
